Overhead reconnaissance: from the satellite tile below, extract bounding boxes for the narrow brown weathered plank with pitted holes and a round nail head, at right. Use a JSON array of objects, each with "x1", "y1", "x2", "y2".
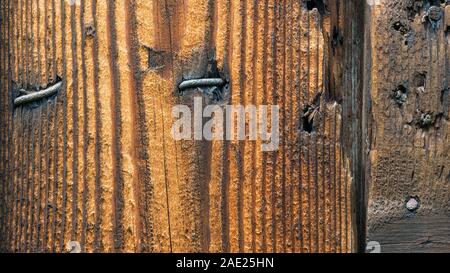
[{"x1": 366, "y1": 0, "x2": 450, "y2": 252}]
